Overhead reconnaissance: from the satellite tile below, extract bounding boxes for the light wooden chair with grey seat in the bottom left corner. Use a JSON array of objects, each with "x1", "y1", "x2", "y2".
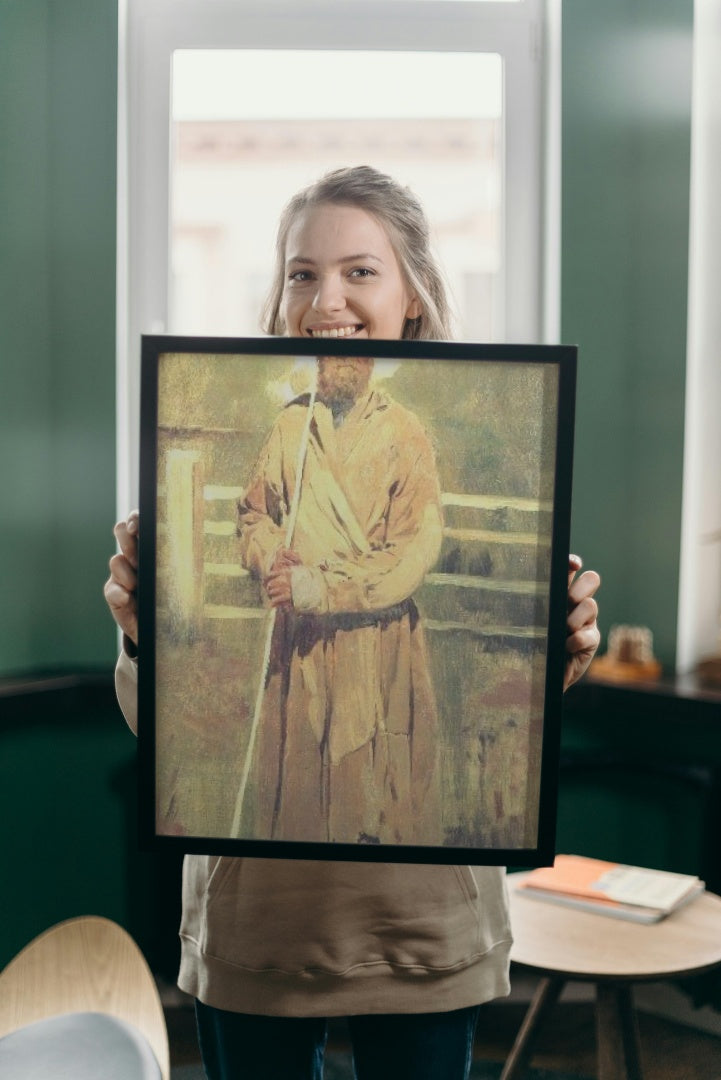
[{"x1": 0, "y1": 916, "x2": 169, "y2": 1080}]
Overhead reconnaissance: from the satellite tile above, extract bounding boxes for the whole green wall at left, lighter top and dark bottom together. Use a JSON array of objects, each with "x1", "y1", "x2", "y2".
[{"x1": 0, "y1": 0, "x2": 129, "y2": 966}]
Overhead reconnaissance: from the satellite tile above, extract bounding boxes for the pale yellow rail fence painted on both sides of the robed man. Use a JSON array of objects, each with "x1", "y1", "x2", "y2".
[{"x1": 158, "y1": 449, "x2": 552, "y2": 643}]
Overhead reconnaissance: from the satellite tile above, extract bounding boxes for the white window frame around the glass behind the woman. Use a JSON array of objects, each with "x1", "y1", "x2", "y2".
[{"x1": 117, "y1": 0, "x2": 560, "y2": 515}]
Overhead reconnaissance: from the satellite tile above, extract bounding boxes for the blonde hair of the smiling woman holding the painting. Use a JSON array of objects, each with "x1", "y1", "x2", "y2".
[{"x1": 262, "y1": 165, "x2": 451, "y2": 340}]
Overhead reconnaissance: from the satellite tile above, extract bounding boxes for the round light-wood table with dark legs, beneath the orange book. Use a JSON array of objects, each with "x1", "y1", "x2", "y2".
[{"x1": 501, "y1": 874, "x2": 721, "y2": 1080}]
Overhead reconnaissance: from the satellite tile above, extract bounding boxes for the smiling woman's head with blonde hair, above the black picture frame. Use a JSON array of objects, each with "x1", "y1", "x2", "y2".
[{"x1": 264, "y1": 166, "x2": 451, "y2": 340}]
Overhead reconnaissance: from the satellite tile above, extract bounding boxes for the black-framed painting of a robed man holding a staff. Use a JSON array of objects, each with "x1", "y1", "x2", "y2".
[{"x1": 138, "y1": 337, "x2": 575, "y2": 866}]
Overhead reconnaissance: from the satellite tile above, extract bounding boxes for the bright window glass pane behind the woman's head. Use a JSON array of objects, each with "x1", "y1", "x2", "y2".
[{"x1": 168, "y1": 49, "x2": 504, "y2": 340}]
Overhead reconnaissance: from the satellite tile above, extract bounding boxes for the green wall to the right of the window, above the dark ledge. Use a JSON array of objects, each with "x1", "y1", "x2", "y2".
[{"x1": 561, "y1": 0, "x2": 693, "y2": 669}]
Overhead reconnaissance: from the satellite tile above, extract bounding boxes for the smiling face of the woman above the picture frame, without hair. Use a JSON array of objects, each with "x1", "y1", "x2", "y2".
[{"x1": 281, "y1": 203, "x2": 421, "y2": 339}]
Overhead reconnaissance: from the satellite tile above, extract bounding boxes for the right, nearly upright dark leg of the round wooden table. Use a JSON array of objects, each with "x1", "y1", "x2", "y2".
[{"x1": 596, "y1": 983, "x2": 643, "y2": 1080}]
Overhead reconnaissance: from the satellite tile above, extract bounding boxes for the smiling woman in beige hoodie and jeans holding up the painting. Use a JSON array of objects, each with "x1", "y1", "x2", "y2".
[{"x1": 106, "y1": 166, "x2": 599, "y2": 1080}]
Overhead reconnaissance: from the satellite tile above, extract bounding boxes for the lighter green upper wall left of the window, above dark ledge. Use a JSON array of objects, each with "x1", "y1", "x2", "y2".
[{"x1": 0, "y1": 0, "x2": 118, "y2": 675}]
